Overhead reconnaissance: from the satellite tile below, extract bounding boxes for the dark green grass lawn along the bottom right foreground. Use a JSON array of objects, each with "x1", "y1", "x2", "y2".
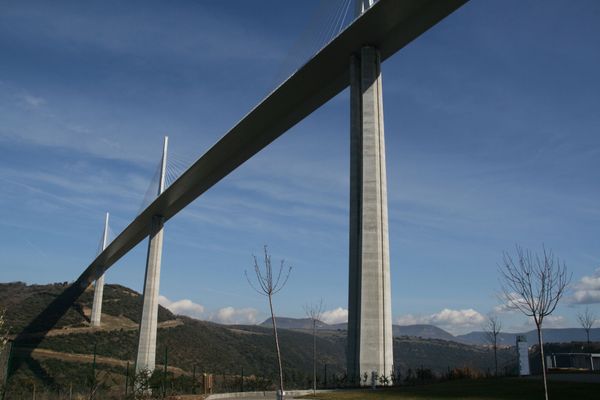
[{"x1": 308, "y1": 378, "x2": 600, "y2": 400}]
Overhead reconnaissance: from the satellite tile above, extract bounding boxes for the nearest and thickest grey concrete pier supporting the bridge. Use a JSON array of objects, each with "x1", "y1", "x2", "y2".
[{"x1": 347, "y1": 0, "x2": 394, "y2": 385}]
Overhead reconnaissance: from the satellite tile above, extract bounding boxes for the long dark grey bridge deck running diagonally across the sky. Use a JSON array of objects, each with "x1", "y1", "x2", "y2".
[{"x1": 76, "y1": 0, "x2": 466, "y2": 288}]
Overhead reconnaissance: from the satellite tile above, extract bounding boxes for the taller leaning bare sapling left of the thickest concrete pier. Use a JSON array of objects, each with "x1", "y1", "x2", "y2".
[{"x1": 244, "y1": 245, "x2": 292, "y2": 398}]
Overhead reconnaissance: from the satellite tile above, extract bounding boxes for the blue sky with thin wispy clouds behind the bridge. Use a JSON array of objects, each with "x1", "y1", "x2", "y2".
[{"x1": 0, "y1": 0, "x2": 600, "y2": 333}]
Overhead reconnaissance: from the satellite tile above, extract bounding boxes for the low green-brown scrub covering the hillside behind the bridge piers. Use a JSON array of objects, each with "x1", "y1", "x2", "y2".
[{"x1": 0, "y1": 283, "x2": 552, "y2": 399}]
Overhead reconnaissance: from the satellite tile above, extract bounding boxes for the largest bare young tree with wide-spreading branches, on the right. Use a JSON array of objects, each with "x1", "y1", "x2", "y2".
[{"x1": 500, "y1": 245, "x2": 571, "y2": 400}]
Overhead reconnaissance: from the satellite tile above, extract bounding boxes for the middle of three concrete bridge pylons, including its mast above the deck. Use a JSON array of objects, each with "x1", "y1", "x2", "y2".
[{"x1": 135, "y1": 136, "x2": 169, "y2": 374}]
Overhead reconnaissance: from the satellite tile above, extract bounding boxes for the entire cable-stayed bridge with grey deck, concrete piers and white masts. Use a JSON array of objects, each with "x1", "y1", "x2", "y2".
[{"x1": 10, "y1": 0, "x2": 466, "y2": 388}]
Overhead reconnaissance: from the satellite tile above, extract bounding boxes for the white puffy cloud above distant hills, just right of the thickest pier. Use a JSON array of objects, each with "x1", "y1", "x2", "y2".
[{"x1": 396, "y1": 308, "x2": 485, "y2": 334}]
